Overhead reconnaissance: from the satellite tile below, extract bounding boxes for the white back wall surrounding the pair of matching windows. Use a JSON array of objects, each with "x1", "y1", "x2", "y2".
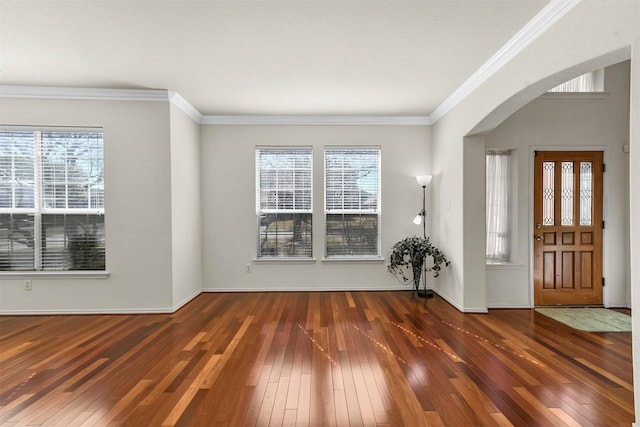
[{"x1": 201, "y1": 125, "x2": 431, "y2": 291}]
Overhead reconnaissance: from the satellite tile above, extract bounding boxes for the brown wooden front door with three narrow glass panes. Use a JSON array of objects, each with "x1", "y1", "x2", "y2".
[{"x1": 533, "y1": 151, "x2": 604, "y2": 306}]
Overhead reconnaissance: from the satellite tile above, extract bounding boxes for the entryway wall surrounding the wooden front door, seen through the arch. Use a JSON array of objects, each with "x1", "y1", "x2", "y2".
[{"x1": 485, "y1": 61, "x2": 631, "y2": 307}]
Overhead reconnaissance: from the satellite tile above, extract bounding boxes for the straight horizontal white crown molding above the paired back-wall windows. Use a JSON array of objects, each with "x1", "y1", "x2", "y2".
[{"x1": 200, "y1": 115, "x2": 431, "y2": 126}]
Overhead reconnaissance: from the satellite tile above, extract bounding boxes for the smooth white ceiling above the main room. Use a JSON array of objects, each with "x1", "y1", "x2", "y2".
[{"x1": 0, "y1": 0, "x2": 549, "y2": 116}]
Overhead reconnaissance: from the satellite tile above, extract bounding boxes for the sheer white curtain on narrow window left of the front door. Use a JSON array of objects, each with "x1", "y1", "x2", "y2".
[{"x1": 487, "y1": 151, "x2": 511, "y2": 262}]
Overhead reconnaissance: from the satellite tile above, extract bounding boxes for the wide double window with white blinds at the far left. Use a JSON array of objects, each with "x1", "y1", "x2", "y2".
[{"x1": 0, "y1": 128, "x2": 105, "y2": 271}]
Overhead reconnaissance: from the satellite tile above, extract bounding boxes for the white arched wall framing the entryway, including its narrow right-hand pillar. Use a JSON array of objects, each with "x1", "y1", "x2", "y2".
[{"x1": 432, "y1": 1, "x2": 640, "y2": 424}]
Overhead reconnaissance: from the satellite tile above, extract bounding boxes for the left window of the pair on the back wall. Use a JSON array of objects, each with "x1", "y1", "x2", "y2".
[{"x1": 256, "y1": 147, "x2": 313, "y2": 258}]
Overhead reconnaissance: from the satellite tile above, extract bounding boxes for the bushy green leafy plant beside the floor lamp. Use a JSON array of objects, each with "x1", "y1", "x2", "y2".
[{"x1": 388, "y1": 236, "x2": 451, "y2": 295}]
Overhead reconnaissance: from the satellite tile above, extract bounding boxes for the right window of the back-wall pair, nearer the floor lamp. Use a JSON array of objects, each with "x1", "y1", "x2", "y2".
[{"x1": 324, "y1": 148, "x2": 380, "y2": 257}]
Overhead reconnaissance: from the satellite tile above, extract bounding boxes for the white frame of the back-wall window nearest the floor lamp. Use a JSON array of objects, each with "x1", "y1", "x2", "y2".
[{"x1": 323, "y1": 145, "x2": 383, "y2": 261}]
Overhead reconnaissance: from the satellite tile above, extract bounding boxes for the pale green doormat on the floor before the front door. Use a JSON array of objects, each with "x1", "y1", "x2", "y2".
[{"x1": 535, "y1": 307, "x2": 631, "y2": 332}]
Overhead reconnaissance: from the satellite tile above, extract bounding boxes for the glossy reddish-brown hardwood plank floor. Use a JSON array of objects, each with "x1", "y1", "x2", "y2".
[{"x1": 0, "y1": 292, "x2": 634, "y2": 426}]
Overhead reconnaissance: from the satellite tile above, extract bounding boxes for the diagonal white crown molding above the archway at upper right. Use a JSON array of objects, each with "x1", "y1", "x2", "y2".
[{"x1": 429, "y1": 0, "x2": 582, "y2": 124}]
